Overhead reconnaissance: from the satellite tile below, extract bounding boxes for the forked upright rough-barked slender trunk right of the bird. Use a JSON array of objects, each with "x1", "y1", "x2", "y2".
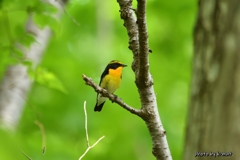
[{"x1": 117, "y1": 0, "x2": 172, "y2": 160}]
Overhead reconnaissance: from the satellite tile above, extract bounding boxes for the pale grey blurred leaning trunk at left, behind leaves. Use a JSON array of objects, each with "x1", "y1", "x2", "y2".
[{"x1": 0, "y1": 0, "x2": 66, "y2": 130}]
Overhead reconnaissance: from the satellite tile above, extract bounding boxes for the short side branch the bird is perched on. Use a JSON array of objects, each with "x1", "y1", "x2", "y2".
[{"x1": 82, "y1": 74, "x2": 144, "y2": 118}]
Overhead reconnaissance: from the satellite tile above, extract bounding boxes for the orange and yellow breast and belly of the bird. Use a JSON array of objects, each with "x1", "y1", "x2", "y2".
[{"x1": 100, "y1": 67, "x2": 122, "y2": 93}]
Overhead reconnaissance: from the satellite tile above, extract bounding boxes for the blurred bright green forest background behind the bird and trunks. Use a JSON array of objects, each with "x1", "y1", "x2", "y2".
[{"x1": 0, "y1": 0, "x2": 197, "y2": 160}]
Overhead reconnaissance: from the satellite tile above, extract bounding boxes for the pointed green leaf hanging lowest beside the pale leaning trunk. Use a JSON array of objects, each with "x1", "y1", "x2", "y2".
[{"x1": 35, "y1": 67, "x2": 67, "y2": 94}]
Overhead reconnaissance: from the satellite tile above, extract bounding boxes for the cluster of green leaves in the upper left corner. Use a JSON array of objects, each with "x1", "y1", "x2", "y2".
[{"x1": 0, "y1": 0, "x2": 62, "y2": 88}]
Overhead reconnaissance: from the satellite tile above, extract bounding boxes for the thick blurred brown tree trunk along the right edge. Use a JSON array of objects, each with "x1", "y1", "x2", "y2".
[{"x1": 183, "y1": 0, "x2": 240, "y2": 160}]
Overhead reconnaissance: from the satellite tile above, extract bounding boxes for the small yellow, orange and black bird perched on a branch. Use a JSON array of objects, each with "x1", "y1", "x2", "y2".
[{"x1": 94, "y1": 60, "x2": 127, "y2": 112}]
